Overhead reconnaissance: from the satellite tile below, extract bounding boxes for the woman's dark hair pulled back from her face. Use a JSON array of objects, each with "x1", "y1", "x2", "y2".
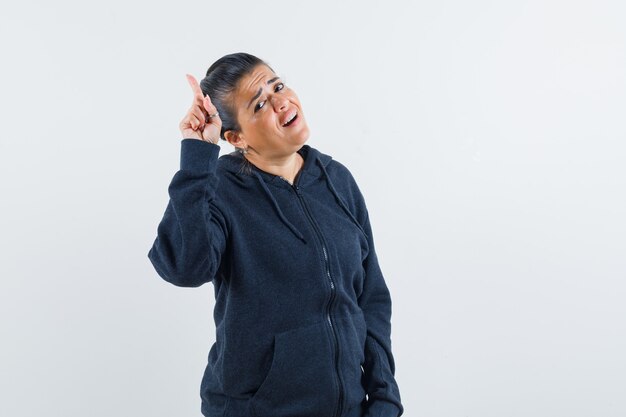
[{"x1": 200, "y1": 52, "x2": 275, "y2": 140}]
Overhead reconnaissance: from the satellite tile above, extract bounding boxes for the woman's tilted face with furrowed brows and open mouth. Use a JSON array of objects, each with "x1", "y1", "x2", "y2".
[{"x1": 227, "y1": 65, "x2": 309, "y2": 155}]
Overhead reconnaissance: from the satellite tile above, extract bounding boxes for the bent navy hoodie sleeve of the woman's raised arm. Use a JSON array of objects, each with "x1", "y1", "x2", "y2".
[{"x1": 148, "y1": 139, "x2": 227, "y2": 287}]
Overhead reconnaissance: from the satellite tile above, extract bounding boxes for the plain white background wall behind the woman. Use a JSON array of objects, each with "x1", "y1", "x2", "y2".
[{"x1": 0, "y1": 0, "x2": 626, "y2": 417}]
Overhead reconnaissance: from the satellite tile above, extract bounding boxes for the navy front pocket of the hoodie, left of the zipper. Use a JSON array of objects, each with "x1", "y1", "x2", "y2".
[{"x1": 250, "y1": 322, "x2": 338, "y2": 417}]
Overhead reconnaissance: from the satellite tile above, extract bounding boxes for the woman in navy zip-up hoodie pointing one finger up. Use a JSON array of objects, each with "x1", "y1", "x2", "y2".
[{"x1": 148, "y1": 53, "x2": 404, "y2": 417}]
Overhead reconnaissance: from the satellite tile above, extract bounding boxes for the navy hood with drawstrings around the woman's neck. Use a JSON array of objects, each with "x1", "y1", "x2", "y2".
[{"x1": 219, "y1": 144, "x2": 361, "y2": 243}]
